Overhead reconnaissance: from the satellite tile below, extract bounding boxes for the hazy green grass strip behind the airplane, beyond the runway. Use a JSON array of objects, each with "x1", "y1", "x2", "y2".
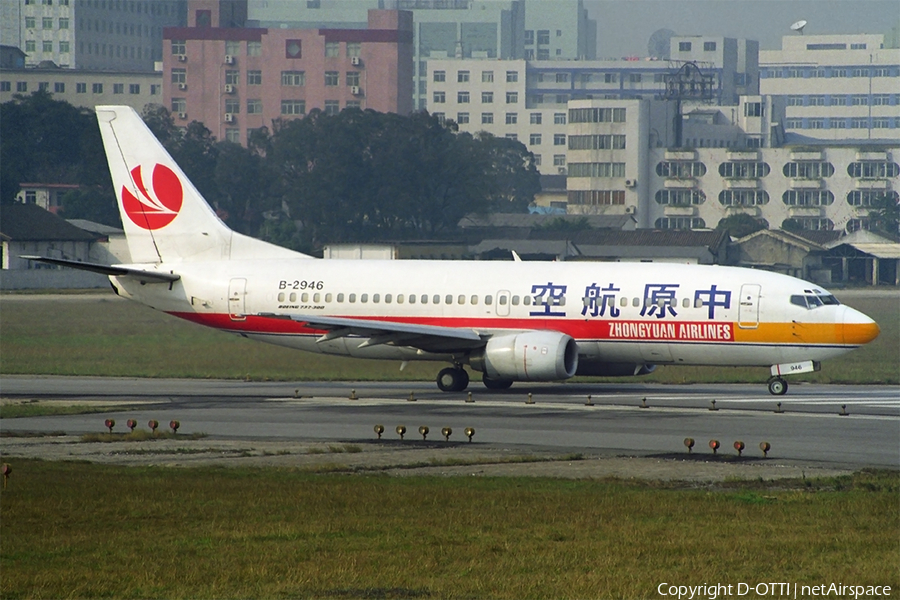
[{"x1": 0, "y1": 295, "x2": 900, "y2": 383}]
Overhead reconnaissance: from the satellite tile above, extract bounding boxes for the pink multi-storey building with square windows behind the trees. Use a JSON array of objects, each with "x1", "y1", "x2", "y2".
[{"x1": 163, "y1": 0, "x2": 413, "y2": 144}]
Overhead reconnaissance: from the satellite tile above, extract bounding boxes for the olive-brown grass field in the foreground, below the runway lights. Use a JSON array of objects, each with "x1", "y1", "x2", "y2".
[{"x1": 0, "y1": 461, "x2": 900, "y2": 598}]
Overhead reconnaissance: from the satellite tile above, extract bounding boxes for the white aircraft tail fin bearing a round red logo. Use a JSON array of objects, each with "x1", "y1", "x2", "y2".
[{"x1": 96, "y1": 106, "x2": 306, "y2": 263}]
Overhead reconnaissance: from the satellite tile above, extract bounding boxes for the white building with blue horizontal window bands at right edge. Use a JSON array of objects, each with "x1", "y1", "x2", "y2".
[{"x1": 759, "y1": 34, "x2": 900, "y2": 144}]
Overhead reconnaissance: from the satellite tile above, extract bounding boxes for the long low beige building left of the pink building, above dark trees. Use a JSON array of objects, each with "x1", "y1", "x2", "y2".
[{"x1": 0, "y1": 68, "x2": 163, "y2": 112}]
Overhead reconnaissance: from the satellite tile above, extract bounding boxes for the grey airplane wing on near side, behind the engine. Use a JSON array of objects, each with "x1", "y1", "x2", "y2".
[{"x1": 259, "y1": 313, "x2": 490, "y2": 352}]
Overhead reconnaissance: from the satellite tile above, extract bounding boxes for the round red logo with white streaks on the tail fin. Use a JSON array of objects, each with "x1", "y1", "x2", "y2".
[{"x1": 122, "y1": 164, "x2": 184, "y2": 230}]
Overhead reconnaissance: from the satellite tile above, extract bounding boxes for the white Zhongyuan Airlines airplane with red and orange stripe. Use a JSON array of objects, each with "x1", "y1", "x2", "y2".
[{"x1": 28, "y1": 106, "x2": 879, "y2": 395}]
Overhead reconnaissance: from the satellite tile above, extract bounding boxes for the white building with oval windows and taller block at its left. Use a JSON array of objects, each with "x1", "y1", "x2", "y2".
[{"x1": 567, "y1": 96, "x2": 900, "y2": 231}]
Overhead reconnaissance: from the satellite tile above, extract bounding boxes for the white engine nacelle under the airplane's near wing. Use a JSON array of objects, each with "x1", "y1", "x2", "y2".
[{"x1": 469, "y1": 331, "x2": 578, "y2": 381}]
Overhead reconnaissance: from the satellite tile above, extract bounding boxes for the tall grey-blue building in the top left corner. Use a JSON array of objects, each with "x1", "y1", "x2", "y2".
[{"x1": 0, "y1": 0, "x2": 187, "y2": 71}]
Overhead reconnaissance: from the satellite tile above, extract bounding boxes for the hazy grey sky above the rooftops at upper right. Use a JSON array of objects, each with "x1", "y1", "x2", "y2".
[{"x1": 584, "y1": 0, "x2": 900, "y2": 58}]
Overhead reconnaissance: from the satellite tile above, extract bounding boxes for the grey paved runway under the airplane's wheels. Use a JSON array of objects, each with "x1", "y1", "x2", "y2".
[{"x1": 0, "y1": 376, "x2": 900, "y2": 469}]
